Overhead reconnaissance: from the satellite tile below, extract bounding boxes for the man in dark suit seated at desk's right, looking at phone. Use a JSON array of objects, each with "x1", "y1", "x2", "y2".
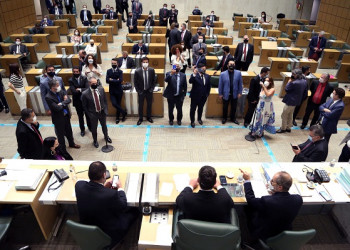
[{"x1": 292, "y1": 125, "x2": 328, "y2": 162}]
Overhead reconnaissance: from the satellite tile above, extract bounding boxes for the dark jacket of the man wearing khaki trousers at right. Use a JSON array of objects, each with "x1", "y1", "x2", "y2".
[{"x1": 282, "y1": 79, "x2": 307, "y2": 106}]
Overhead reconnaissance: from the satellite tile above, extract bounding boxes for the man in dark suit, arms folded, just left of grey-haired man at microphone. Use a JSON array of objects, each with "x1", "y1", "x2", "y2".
[{"x1": 69, "y1": 67, "x2": 91, "y2": 136}]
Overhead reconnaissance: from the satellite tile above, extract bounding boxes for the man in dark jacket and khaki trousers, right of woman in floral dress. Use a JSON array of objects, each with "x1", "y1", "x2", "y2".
[{"x1": 276, "y1": 69, "x2": 307, "y2": 133}]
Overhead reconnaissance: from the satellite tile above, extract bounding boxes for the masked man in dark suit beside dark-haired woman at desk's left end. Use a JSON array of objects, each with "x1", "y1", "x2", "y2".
[{"x1": 16, "y1": 108, "x2": 43, "y2": 160}]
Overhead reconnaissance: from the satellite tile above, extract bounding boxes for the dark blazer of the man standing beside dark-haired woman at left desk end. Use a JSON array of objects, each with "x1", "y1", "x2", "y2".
[{"x1": 16, "y1": 119, "x2": 43, "y2": 160}]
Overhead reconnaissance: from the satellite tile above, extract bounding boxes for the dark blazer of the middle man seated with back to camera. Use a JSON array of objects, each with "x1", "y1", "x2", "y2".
[{"x1": 176, "y1": 187, "x2": 234, "y2": 223}]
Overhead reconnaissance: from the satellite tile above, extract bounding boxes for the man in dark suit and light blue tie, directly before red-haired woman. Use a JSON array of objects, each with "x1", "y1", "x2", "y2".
[{"x1": 163, "y1": 64, "x2": 187, "y2": 126}]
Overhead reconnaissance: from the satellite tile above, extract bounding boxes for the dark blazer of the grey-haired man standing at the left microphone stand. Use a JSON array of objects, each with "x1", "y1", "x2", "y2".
[{"x1": 81, "y1": 86, "x2": 108, "y2": 117}]
